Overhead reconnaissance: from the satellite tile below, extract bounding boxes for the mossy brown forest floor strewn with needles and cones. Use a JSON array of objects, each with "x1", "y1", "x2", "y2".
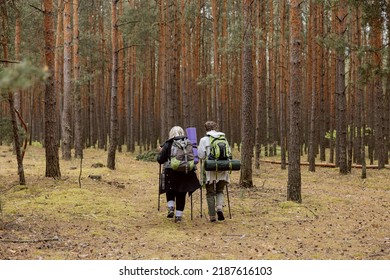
[{"x1": 0, "y1": 146, "x2": 390, "y2": 260}]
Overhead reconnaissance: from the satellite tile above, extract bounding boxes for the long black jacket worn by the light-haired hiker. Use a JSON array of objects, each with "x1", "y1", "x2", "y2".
[{"x1": 157, "y1": 136, "x2": 201, "y2": 195}]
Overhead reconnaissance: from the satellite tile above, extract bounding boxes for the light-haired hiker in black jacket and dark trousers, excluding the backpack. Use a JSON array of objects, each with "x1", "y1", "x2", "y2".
[{"x1": 157, "y1": 126, "x2": 200, "y2": 223}]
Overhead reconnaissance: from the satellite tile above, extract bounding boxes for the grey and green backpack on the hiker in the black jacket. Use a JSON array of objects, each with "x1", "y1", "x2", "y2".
[{"x1": 170, "y1": 138, "x2": 195, "y2": 173}]
